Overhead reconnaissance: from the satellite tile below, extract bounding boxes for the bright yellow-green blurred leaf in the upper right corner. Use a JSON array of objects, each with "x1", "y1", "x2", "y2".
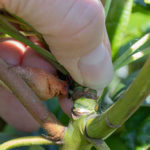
[{"x1": 119, "y1": 0, "x2": 150, "y2": 55}]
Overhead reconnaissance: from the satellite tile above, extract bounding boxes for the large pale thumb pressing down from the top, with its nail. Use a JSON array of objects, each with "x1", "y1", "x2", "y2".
[{"x1": 0, "y1": 0, "x2": 113, "y2": 89}]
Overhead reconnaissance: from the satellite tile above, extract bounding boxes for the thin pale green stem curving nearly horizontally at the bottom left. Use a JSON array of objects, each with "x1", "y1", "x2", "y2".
[{"x1": 0, "y1": 136, "x2": 55, "y2": 150}]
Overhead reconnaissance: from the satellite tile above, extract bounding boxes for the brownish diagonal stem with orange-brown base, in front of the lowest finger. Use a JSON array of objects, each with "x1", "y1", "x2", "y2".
[{"x1": 0, "y1": 59, "x2": 65, "y2": 141}]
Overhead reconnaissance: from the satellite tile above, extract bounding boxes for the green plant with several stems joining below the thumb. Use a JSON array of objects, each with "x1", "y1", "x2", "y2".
[{"x1": 0, "y1": 0, "x2": 150, "y2": 150}]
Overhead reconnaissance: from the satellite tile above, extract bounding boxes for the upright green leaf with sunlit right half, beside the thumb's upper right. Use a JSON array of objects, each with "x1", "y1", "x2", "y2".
[{"x1": 107, "y1": 0, "x2": 133, "y2": 59}]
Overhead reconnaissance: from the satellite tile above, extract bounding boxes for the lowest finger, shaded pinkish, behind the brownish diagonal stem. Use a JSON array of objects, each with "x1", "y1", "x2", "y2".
[{"x1": 0, "y1": 87, "x2": 40, "y2": 132}]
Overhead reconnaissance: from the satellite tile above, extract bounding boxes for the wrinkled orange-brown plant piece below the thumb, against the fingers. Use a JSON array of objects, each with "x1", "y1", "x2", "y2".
[{"x1": 11, "y1": 67, "x2": 67, "y2": 100}]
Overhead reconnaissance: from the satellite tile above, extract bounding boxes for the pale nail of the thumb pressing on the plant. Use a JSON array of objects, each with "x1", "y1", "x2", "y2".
[{"x1": 78, "y1": 42, "x2": 113, "y2": 89}]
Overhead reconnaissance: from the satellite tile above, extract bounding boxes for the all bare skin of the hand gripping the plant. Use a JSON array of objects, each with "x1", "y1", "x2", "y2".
[{"x1": 0, "y1": 0, "x2": 113, "y2": 131}]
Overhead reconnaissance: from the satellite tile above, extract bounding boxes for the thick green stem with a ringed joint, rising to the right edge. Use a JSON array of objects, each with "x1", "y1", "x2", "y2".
[{"x1": 86, "y1": 58, "x2": 150, "y2": 139}]
